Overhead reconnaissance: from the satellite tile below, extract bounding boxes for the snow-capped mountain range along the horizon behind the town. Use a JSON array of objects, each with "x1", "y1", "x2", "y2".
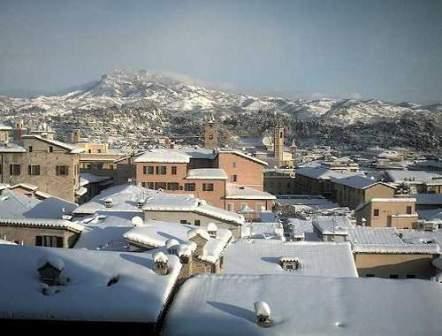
[{"x1": 0, "y1": 71, "x2": 442, "y2": 150}]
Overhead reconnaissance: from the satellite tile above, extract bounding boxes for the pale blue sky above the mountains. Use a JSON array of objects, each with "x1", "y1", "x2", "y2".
[{"x1": 0, "y1": 0, "x2": 442, "y2": 103}]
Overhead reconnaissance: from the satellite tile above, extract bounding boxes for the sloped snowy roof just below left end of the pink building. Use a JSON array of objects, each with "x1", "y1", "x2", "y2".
[{"x1": 74, "y1": 184, "x2": 148, "y2": 215}]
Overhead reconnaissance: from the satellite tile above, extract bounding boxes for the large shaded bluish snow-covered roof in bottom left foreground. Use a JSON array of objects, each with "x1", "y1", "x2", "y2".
[{"x1": 0, "y1": 245, "x2": 181, "y2": 323}]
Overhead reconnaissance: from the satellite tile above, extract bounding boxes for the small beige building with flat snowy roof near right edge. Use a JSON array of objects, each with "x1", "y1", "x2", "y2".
[{"x1": 355, "y1": 198, "x2": 418, "y2": 229}]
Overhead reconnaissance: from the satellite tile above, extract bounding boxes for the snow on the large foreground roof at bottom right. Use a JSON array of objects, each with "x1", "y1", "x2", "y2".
[{"x1": 163, "y1": 274, "x2": 442, "y2": 336}]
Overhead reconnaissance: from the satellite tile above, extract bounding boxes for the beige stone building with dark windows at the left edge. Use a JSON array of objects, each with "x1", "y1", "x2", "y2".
[{"x1": 0, "y1": 135, "x2": 82, "y2": 202}]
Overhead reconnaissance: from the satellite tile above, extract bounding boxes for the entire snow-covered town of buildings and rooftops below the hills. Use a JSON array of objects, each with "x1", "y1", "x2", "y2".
[{"x1": 0, "y1": 116, "x2": 442, "y2": 335}]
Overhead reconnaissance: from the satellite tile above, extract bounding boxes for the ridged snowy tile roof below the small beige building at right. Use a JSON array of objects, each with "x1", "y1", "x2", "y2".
[{"x1": 348, "y1": 226, "x2": 440, "y2": 254}]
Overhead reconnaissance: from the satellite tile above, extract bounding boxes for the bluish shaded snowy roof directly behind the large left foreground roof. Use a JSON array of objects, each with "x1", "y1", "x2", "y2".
[{"x1": 74, "y1": 211, "x2": 135, "y2": 251}]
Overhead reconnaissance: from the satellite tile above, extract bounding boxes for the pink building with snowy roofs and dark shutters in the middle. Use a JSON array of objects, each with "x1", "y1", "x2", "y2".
[{"x1": 135, "y1": 148, "x2": 275, "y2": 217}]
